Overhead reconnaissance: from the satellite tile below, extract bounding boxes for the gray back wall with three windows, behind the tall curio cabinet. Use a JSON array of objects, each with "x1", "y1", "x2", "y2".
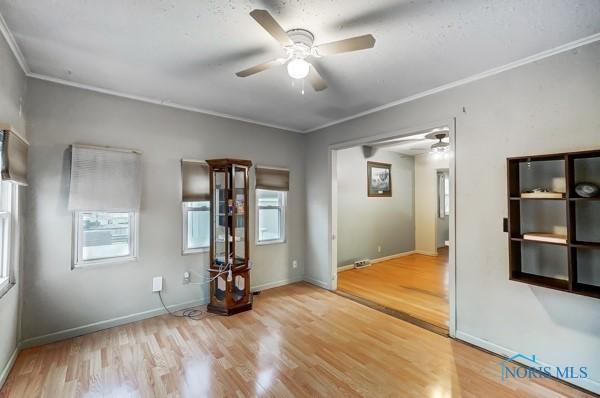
[{"x1": 23, "y1": 79, "x2": 305, "y2": 342}]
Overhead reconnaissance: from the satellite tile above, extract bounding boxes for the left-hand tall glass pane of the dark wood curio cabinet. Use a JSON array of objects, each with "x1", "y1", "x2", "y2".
[{"x1": 213, "y1": 170, "x2": 230, "y2": 266}]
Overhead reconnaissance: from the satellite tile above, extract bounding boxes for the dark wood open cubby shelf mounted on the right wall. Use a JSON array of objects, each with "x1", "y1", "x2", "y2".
[{"x1": 507, "y1": 150, "x2": 600, "y2": 298}]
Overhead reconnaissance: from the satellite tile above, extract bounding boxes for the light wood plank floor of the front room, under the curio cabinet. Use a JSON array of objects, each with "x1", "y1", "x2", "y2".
[{"x1": 0, "y1": 283, "x2": 588, "y2": 398}]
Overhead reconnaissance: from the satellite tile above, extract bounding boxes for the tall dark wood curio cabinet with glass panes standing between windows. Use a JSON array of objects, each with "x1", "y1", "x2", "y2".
[{"x1": 206, "y1": 159, "x2": 252, "y2": 315}]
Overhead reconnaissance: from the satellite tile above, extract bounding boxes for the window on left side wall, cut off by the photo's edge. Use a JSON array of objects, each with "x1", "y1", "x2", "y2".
[{"x1": 0, "y1": 181, "x2": 14, "y2": 295}]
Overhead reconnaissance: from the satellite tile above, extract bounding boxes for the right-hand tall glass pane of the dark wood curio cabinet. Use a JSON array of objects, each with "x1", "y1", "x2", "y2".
[{"x1": 232, "y1": 166, "x2": 248, "y2": 266}]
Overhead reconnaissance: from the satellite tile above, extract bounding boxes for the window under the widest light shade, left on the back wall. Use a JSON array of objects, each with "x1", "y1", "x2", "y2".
[{"x1": 74, "y1": 211, "x2": 137, "y2": 267}]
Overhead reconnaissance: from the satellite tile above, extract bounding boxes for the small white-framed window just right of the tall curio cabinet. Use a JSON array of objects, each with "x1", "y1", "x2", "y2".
[{"x1": 256, "y1": 189, "x2": 286, "y2": 244}]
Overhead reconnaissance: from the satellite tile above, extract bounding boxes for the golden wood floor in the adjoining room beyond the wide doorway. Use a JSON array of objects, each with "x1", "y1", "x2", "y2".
[{"x1": 338, "y1": 248, "x2": 448, "y2": 330}]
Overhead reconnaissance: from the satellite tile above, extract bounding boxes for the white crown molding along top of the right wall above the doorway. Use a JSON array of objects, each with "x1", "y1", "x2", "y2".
[{"x1": 302, "y1": 33, "x2": 600, "y2": 133}]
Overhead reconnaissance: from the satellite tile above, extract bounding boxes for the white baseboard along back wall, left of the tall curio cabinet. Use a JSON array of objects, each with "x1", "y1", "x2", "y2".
[{"x1": 21, "y1": 297, "x2": 208, "y2": 348}]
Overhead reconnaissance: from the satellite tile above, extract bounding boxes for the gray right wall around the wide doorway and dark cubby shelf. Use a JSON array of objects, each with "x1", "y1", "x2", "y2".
[{"x1": 306, "y1": 43, "x2": 600, "y2": 392}]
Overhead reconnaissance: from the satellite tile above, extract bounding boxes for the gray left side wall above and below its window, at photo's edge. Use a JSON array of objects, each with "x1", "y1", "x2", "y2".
[{"x1": 0, "y1": 31, "x2": 27, "y2": 375}]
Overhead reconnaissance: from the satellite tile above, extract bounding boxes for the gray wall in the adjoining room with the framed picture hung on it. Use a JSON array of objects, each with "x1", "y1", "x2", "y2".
[{"x1": 337, "y1": 147, "x2": 415, "y2": 266}]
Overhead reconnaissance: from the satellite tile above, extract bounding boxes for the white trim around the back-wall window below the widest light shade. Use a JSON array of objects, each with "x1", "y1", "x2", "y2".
[{"x1": 71, "y1": 210, "x2": 139, "y2": 269}]
